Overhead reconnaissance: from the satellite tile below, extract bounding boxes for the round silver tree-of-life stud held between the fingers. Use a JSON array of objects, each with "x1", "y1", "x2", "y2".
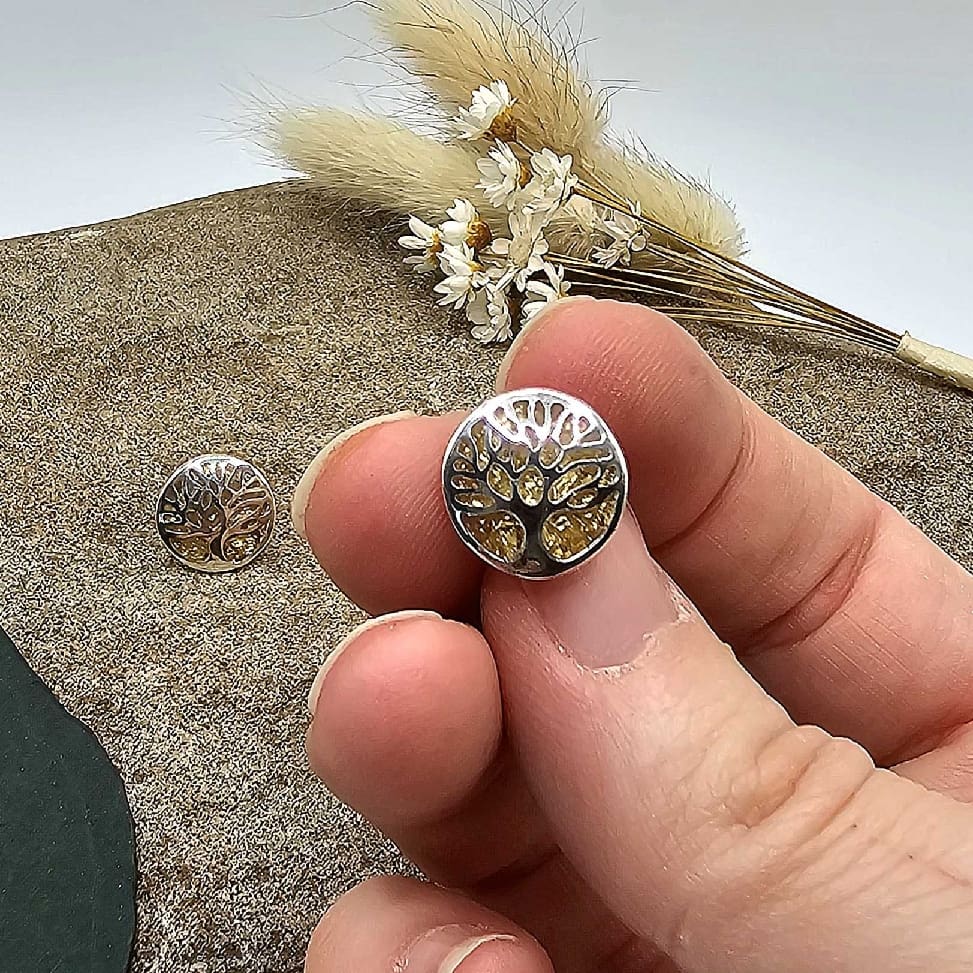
[{"x1": 443, "y1": 389, "x2": 628, "y2": 580}]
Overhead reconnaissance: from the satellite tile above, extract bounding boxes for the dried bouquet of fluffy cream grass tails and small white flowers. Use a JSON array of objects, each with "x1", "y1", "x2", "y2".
[{"x1": 274, "y1": 0, "x2": 973, "y2": 389}]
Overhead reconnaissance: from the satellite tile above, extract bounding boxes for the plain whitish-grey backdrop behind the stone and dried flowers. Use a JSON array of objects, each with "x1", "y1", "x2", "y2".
[{"x1": 0, "y1": 0, "x2": 973, "y2": 353}]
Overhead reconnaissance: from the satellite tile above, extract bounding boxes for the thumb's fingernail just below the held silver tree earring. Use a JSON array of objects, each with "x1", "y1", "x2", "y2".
[{"x1": 523, "y1": 510, "x2": 682, "y2": 669}]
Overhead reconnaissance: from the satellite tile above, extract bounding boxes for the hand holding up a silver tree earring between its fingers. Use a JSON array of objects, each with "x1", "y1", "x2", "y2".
[{"x1": 296, "y1": 300, "x2": 973, "y2": 973}]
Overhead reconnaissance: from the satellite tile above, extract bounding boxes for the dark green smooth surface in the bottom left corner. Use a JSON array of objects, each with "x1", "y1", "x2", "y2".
[{"x1": 0, "y1": 632, "x2": 135, "y2": 973}]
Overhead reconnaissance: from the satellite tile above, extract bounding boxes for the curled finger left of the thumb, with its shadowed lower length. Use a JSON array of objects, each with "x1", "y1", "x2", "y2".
[{"x1": 307, "y1": 612, "x2": 648, "y2": 973}]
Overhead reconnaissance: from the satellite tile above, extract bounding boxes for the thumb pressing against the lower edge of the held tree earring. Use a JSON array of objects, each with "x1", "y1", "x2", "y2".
[{"x1": 483, "y1": 513, "x2": 973, "y2": 973}]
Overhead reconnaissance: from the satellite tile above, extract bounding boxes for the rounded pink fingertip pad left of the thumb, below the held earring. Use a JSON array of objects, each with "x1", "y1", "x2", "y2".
[{"x1": 308, "y1": 613, "x2": 502, "y2": 828}]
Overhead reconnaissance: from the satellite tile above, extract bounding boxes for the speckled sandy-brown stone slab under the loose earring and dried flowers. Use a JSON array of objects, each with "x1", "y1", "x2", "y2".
[{"x1": 0, "y1": 185, "x2": 973, "y2": 973}]
